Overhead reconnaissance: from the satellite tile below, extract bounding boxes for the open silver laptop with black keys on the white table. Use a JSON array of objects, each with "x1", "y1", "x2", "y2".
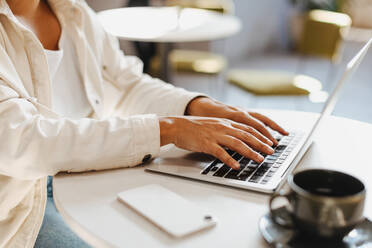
[{"x1": 146, "y1": 39, "x2": 372, "y2": 193}]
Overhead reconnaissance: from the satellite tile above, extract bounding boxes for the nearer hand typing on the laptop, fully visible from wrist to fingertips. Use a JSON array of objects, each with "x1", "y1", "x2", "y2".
[{"x1": 159, "y1": 116, "x2": 274, "y2": 169}]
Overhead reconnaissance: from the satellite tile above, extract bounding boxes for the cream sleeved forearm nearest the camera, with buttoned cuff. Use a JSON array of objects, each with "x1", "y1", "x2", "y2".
[{"x1": 0, "y1": 99, "x2": 160, "y2": 179}]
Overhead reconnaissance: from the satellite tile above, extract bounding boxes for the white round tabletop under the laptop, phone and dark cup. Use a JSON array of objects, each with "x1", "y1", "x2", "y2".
[{"x1": 53, "y1": 110, "x2": 372, "y2": 247}]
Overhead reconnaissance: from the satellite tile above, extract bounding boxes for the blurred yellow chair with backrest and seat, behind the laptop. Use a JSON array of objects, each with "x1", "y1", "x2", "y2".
[{"x1": 228, "y1": 10, "x2": 351, "y2": 101}]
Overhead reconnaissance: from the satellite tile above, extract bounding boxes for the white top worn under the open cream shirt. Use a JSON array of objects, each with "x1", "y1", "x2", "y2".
[{"x1": 45, "y1": 31, "x2": 92, "y2": 119}]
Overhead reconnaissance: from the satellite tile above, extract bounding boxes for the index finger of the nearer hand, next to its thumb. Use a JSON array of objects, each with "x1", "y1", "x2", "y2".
[{"x1": 218, "y1": 135, "x2": 264, "y2": 163}]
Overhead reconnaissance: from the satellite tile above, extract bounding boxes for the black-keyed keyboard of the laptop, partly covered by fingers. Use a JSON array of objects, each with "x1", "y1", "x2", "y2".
[{"x1": 201, "y1": 133, "x2": 300, "y2": 184}]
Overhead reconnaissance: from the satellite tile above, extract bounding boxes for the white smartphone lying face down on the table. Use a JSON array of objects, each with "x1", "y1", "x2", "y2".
[{"x1": 118, "y1": 184, "x2": 217, "y2": 238}]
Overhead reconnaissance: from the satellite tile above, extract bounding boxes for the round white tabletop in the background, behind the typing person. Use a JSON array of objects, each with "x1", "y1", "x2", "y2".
[{"x1": 99, "y1": 7, "x2": 241, "y2": 42}]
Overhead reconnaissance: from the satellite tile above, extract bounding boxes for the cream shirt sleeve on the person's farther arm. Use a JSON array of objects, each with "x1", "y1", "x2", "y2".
[{"x1": 102, "y1": 33, "x2": 204, "y2": 116}]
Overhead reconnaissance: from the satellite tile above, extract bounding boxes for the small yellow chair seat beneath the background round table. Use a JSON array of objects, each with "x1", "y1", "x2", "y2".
[{"x1": 169, "y1": 50, "x2": 226, "y2": 74}]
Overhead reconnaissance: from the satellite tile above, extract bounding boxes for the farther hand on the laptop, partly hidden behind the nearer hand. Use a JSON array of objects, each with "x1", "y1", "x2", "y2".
[{"x1": 186, "y1": 97, "x2": 288, "y2": 145}]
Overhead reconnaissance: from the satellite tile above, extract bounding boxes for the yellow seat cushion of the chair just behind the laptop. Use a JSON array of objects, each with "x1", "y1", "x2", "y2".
[{"x1": 228, "y1": 70, "x2": 322, "y2": 95}]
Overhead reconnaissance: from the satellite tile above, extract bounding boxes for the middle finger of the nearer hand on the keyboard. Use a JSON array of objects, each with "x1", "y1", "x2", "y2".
[{"x1": 227, "y1": 128, "x2": 274, "y2": 154}]
